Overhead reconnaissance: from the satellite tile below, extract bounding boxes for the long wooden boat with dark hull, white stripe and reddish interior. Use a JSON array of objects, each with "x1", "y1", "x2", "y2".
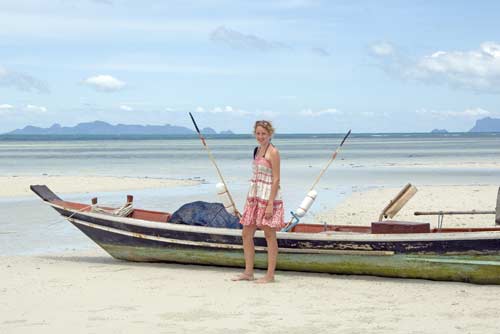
[{"x1": 31, "y1": 185, "x2": 500, "y2": 284}]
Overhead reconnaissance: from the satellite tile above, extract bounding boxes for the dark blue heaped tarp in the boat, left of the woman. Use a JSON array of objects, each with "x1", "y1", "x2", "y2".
[{"x1": 169, "y1": 201, "x2": 242, "y2": 229}]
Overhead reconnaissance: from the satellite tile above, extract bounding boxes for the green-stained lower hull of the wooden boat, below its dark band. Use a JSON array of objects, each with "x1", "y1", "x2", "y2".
[{"x1": 70, "y1": 219, "x2": 500, "y2": 284}]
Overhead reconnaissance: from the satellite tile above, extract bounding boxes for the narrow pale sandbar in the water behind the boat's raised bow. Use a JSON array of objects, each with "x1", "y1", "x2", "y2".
[{"x1": 0, "y1": 175, "x2": 203, "y2": 198}]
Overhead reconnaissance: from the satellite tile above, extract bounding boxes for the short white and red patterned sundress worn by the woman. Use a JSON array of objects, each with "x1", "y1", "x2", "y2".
[{"x1": 240, "y1": 148, "x2": 285, "y2": 230}]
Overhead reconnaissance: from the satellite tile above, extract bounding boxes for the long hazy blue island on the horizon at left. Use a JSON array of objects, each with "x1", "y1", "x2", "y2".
[{"x1": 6, "y1": 121, "x2": 233, "y2": 135}]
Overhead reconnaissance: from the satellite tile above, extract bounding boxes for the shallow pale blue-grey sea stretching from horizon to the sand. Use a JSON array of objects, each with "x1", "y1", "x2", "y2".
[{"x1": 0, "y1": 133, "x2": 500, "y2": 255}]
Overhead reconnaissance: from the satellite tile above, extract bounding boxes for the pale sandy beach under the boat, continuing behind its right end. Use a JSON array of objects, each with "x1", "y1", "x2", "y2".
[{"x1": 0, "y1": 185, "x2": 500, "y2": 334}]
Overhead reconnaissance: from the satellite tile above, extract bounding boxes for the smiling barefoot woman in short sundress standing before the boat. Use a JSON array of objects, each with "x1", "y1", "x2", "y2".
[{"x1": 233, "y1": 121, "x2": 285, "y2": 283}]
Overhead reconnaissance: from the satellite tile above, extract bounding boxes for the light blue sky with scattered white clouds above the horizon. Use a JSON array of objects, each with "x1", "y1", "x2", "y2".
[{"x1": 0, "y1": 0, "x2": 500, "y2": 133}]
